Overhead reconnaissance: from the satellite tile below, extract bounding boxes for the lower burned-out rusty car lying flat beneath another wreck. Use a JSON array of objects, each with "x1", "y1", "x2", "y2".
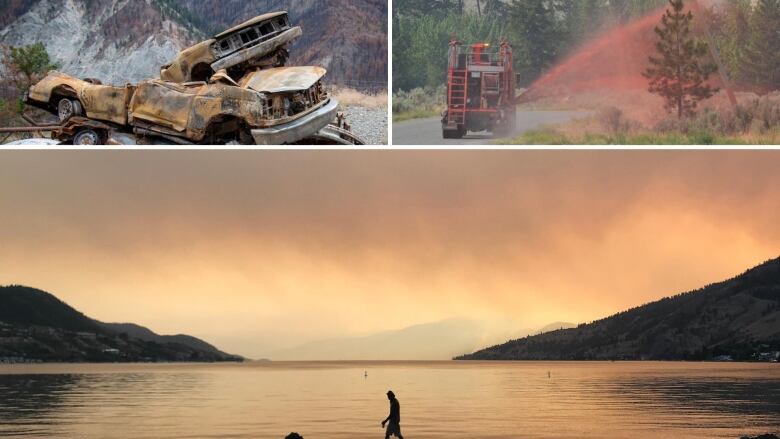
[{"x1": 27, "y1": 67, "x2": 338, "y2": 145}]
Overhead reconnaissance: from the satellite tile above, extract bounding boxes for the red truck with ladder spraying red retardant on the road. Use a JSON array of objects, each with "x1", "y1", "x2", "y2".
[{"x1": 442, "y1": 40, "x2": 517, "y2": 139}]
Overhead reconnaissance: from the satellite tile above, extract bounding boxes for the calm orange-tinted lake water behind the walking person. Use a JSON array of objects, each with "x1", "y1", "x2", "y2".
[{"x1": 0, "y1": 362, "x2": 780, "y2": 439}]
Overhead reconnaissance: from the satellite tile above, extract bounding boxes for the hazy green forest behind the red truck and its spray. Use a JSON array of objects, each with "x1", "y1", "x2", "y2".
[{"x1": 393, "y1": 0, "x2": 780, "y2": 90}]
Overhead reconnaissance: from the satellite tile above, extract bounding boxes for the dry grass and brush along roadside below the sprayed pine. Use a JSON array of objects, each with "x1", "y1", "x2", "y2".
[{"x1": 510, "y1": 91, "x2": 780, "y2": 145}]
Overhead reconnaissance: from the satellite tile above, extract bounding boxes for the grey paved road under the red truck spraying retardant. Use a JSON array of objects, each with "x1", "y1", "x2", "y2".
[{"x1": 393, "y1": 111, "x2": 590, "y2": 145}]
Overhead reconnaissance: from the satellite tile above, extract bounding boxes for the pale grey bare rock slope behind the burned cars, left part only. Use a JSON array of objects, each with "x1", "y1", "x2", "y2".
[{"x1": 0, "y1": 0, "x2": 203, "y2": 84}]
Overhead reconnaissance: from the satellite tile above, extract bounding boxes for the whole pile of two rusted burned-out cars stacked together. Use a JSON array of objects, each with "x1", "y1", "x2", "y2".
[{"x1": 25, "y1": 12, "x2": 364, "y2": 145}]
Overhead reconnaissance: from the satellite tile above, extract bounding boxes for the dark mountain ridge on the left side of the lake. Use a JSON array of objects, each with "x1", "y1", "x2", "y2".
[{"x1": 0, "y1": 286, "x2": 242, "y2": 362}]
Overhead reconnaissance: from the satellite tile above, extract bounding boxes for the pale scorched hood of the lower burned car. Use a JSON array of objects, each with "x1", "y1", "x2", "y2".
[{"x1": 241, "y1": 67, "x2": 327, "y2": 94}]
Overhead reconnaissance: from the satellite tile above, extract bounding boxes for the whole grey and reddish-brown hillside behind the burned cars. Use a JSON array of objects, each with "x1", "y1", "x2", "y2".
[{"x1": 0, "y1": 0, "x2": 387, "y2": 88}]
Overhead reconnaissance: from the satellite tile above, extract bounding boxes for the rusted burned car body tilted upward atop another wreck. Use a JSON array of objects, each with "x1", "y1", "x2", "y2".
[{"x1": 160, "y1": 12, "x2": 303, "y2": 82}]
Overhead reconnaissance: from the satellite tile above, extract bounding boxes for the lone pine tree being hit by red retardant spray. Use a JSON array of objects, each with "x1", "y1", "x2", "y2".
[{"x1": 644, "y1": 0, "x2": 718, "y2": 118}]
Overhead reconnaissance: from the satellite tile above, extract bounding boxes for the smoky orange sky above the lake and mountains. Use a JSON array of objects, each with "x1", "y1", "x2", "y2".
[{"x1": 0, "y1": 151, "x2": 780, "y2": 357}]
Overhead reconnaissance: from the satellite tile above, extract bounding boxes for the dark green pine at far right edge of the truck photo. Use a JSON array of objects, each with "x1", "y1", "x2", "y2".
[{"x1": 743, "y1": 0, "x2": 780, "y2": 90}]
